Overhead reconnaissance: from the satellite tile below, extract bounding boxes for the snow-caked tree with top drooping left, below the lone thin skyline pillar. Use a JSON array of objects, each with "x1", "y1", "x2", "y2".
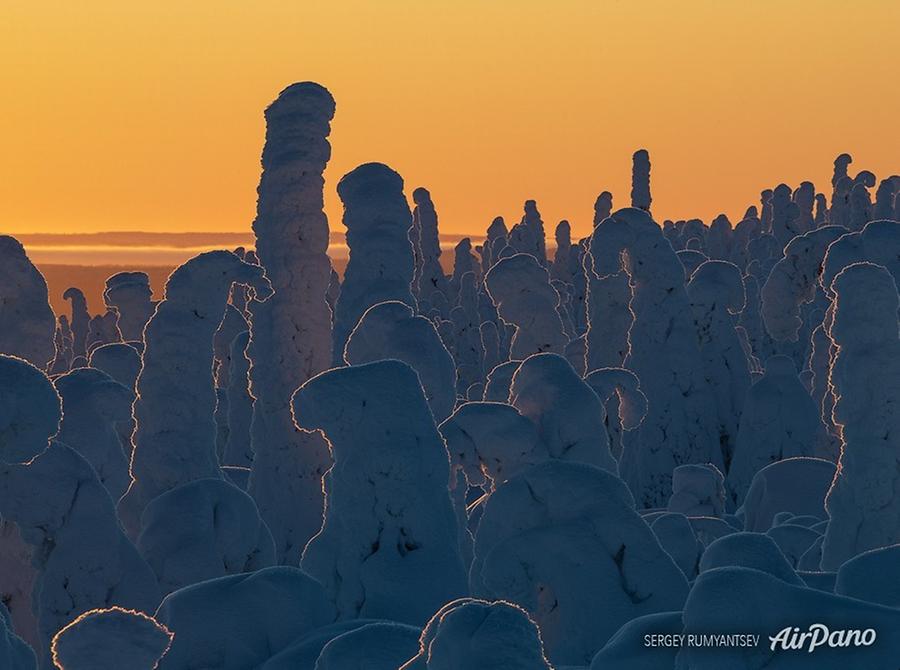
[{"x1": 591, "y1": 208, "x2": 722, "y2": 507}]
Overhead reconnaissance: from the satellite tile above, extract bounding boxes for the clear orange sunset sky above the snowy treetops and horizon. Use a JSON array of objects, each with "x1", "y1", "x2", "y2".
[{"x1": 0, "y1": 0, "x2": 900, "y2": 239}]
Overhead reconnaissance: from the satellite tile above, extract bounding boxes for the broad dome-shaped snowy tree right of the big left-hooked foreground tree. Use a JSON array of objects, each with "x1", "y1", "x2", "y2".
[{"x1": 470, "y1": 460, "x2": 687, "y2": 665}]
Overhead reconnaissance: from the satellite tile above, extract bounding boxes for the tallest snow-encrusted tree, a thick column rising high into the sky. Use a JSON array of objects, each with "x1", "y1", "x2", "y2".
[{"x1": 247, "y1": 82, "x2": 334, "y2": 565}]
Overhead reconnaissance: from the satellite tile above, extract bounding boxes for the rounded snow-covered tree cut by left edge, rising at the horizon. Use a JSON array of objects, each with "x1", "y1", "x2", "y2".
[{"x1": 0, "y1": 235, "x2": 56, "y2": 370}]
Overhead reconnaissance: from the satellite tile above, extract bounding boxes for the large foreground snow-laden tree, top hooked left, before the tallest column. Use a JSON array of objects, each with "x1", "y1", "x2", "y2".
[{"x1": 294, "y1": 360, "x2": 466, "y2": 625}]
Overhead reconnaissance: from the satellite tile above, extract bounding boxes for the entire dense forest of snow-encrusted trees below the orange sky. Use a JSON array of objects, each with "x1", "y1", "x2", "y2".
[{"x1": 0, "y1": 82, "x2": 900, "y2": 670}]
